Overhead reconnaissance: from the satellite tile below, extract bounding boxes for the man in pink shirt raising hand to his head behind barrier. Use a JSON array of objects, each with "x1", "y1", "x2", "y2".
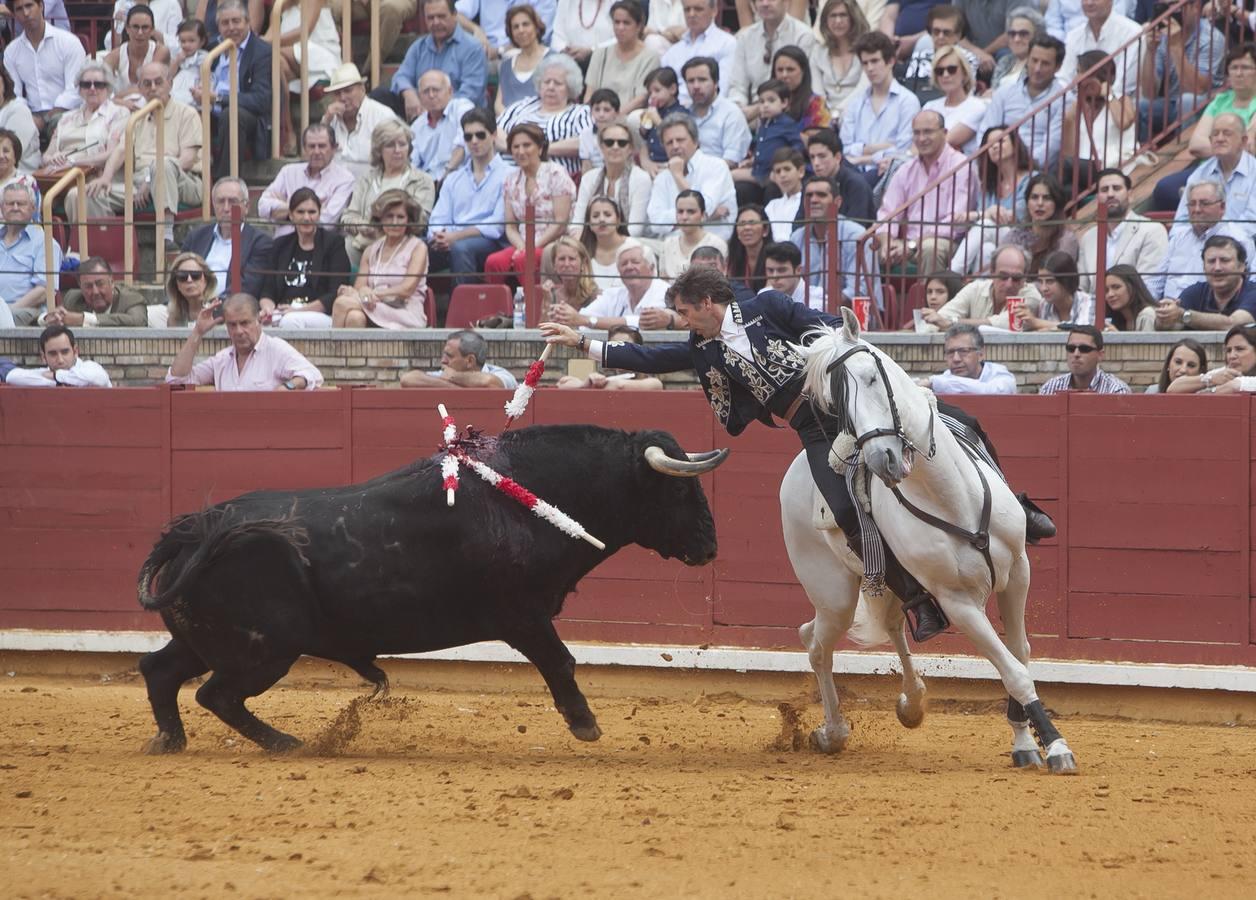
[{"x1": 166, "y1": 294, "x2": 323, "y2": 390}]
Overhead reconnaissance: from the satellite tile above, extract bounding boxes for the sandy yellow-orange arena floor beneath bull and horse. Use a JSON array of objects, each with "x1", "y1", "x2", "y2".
[{"x1": 0, "y1": 662, "x2": 1256, "y2": 900}]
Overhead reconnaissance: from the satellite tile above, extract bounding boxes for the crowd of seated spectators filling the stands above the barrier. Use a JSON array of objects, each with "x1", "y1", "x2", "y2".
[{"x1": 0, "y1": 0, "x2": 1256, "y2": 389}]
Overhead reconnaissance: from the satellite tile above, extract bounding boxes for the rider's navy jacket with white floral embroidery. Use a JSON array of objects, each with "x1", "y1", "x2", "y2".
[{"x1": 602, "y1": 291, "x2": 842, "y2": 434}]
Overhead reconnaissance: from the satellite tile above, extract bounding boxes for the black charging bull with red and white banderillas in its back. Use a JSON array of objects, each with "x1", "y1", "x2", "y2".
[{"x1": 139, "y1": 426, "x2": 727, "y2": 753}]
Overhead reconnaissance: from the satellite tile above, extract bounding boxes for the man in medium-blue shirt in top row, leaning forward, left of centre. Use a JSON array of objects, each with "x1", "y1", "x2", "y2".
[{"x1": 371, "y1": 0, "x2": 487, "y2": 122}]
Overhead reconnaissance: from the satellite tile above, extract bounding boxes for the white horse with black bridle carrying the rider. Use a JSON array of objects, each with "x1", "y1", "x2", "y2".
[{"x1": 781, "y1": 309, "x2": 1076, "y2": 773}]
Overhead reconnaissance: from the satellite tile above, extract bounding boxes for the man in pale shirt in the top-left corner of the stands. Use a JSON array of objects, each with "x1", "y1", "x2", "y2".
[{"x1": 4, "y1": 0, "x2": 87, "y2": 136}]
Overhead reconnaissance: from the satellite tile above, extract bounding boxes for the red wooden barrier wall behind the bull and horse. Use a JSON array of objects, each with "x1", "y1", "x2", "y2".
[{"x1": 0, "y1": 388, "x2": 1256, "y2": 665}]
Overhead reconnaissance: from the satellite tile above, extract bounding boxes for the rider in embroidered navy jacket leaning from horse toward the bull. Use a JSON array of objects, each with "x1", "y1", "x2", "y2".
[{"x1": 541, "y1": 266, "x2": 1055, "y2": 641}]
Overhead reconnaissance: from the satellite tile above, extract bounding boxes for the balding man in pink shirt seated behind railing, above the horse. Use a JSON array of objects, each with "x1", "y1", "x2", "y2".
[{"x1": 877, "y1": 109, "x2": 972, "y2": 272}]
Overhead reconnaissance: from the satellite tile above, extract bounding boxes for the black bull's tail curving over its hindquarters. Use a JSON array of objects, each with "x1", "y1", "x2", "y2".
[{"x1": 137, "y1": 502, "x2": 309, "y2": 610}]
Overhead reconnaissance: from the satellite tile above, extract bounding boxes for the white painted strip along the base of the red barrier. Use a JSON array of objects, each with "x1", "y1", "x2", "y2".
[{"x1": 0, "y1": 629, "x2": 1256, "y2": 693}]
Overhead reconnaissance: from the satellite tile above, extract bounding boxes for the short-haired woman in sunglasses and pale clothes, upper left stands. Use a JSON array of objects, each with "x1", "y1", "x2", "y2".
[{"x1": 43, "y1": 60, "x2": 126, "y2": 171}]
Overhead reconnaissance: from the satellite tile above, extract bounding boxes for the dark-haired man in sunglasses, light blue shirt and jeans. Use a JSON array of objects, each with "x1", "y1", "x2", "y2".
[{"x1": 427, "y1": 108, "x2": 514, "y2": 285}]
